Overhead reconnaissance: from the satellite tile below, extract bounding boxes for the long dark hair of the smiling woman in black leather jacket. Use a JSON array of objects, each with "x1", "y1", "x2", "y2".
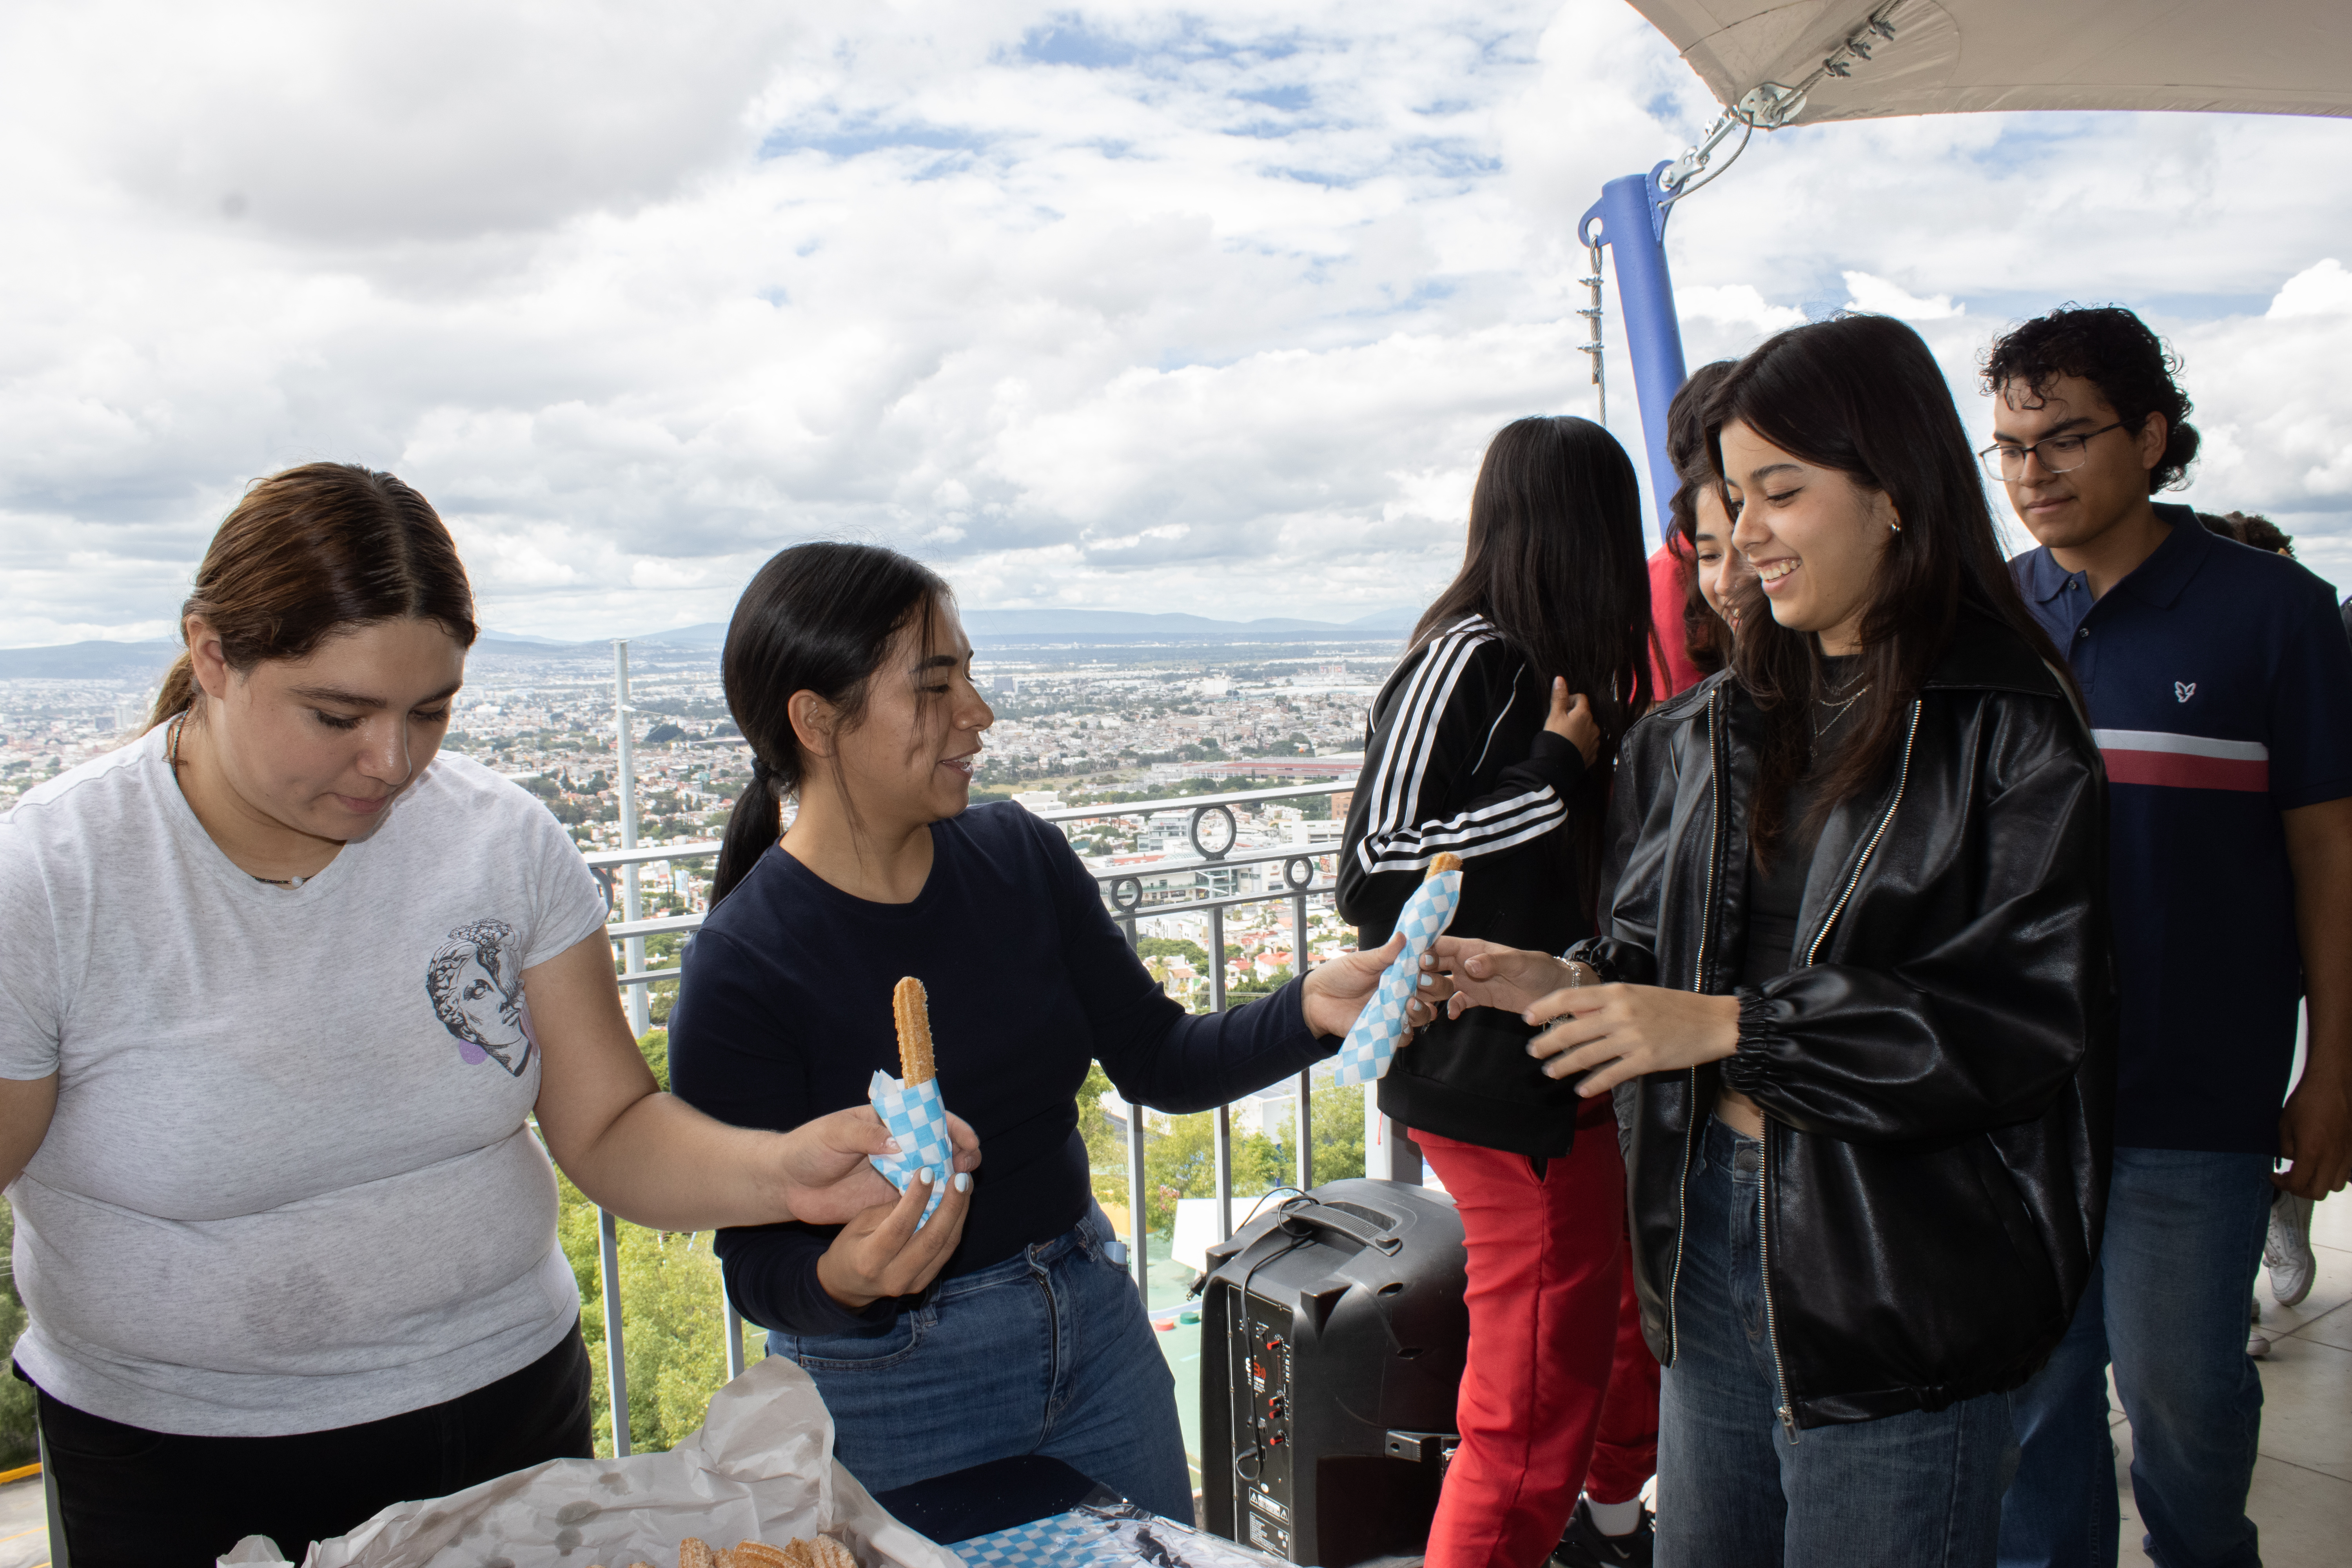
[{"x1": 1708, "y1": 315, "x2": 2065, "y2": 858}]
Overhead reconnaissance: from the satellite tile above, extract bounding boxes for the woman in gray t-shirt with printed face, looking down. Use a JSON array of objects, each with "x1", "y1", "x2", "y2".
[{"x1": 0, "y1": 463, "x2": 976, "y2": 1568}]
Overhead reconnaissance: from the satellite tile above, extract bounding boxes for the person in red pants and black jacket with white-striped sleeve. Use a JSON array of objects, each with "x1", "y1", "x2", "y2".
[{"x1": 1338, "y1": 418, "x2": 1656, "y2": 1568}]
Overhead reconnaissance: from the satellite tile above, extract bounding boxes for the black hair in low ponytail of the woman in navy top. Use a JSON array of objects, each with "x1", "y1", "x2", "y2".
[{"x1": 710, "y1": 541, "x2": 953, "y2": 905}]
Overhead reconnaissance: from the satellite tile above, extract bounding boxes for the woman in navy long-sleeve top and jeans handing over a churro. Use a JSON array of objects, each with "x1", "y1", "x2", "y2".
[{"x1": 670, "y1": 543, "x2": 1390, "y2": 1516}]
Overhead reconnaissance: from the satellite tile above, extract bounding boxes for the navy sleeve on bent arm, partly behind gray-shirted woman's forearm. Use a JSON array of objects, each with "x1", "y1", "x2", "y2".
[{"x1": 670, "y1": 929, "x2": 875, "y2": 1333}]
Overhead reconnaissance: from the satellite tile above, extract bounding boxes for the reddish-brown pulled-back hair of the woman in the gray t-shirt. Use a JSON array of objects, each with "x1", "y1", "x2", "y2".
[{"x1": 148, "y1": 463, "x2": 475, "y2": 729}]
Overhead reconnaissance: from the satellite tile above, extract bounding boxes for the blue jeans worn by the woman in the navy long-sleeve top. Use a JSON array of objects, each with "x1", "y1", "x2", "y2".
[{"x1": 767, "y1": 1208, "x2": 1192, "y2": 1521}]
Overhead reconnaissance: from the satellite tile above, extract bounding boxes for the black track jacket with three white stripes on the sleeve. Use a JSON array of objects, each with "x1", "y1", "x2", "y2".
[{"x1": 1338, "y1": 616, "x2": 1606, "y2": 1157}]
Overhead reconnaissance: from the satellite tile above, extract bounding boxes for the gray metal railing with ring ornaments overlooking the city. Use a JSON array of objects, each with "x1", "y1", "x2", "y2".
[{"x1": 583, "y1": 771, "x2": 1374, "y2": 1455}]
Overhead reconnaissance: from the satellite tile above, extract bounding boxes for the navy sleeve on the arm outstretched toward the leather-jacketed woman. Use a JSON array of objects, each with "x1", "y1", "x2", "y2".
[{"x1": 1037, "y1": 823, "x2": 1338, "y2": 1114}]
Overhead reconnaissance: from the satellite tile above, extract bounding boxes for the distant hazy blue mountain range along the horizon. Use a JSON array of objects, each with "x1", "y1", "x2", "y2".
[{"x1": 0, "y1": 609, "x2": 1421, "y2": 682}]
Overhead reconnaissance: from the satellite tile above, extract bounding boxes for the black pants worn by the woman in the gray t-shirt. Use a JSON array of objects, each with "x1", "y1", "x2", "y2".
[{"x1": 16, "y1": 1323, "x2": 593, "y2": 1568}]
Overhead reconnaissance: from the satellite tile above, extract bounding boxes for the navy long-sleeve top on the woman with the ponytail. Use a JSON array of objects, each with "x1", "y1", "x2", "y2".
[{"x1": 670, "y1": 804, "x2": 1338, "y2": 1333}]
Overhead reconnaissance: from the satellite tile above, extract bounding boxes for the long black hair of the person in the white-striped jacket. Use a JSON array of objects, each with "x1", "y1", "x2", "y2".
[{"x1": 1406, "y1": 416, "x2": 1651, "y2": 893}]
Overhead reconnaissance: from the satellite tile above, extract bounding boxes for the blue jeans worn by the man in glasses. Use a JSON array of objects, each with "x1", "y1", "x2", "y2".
[{"x1": 2002, "y1": 1150, "x2": 2274, "y2": 1568}]
